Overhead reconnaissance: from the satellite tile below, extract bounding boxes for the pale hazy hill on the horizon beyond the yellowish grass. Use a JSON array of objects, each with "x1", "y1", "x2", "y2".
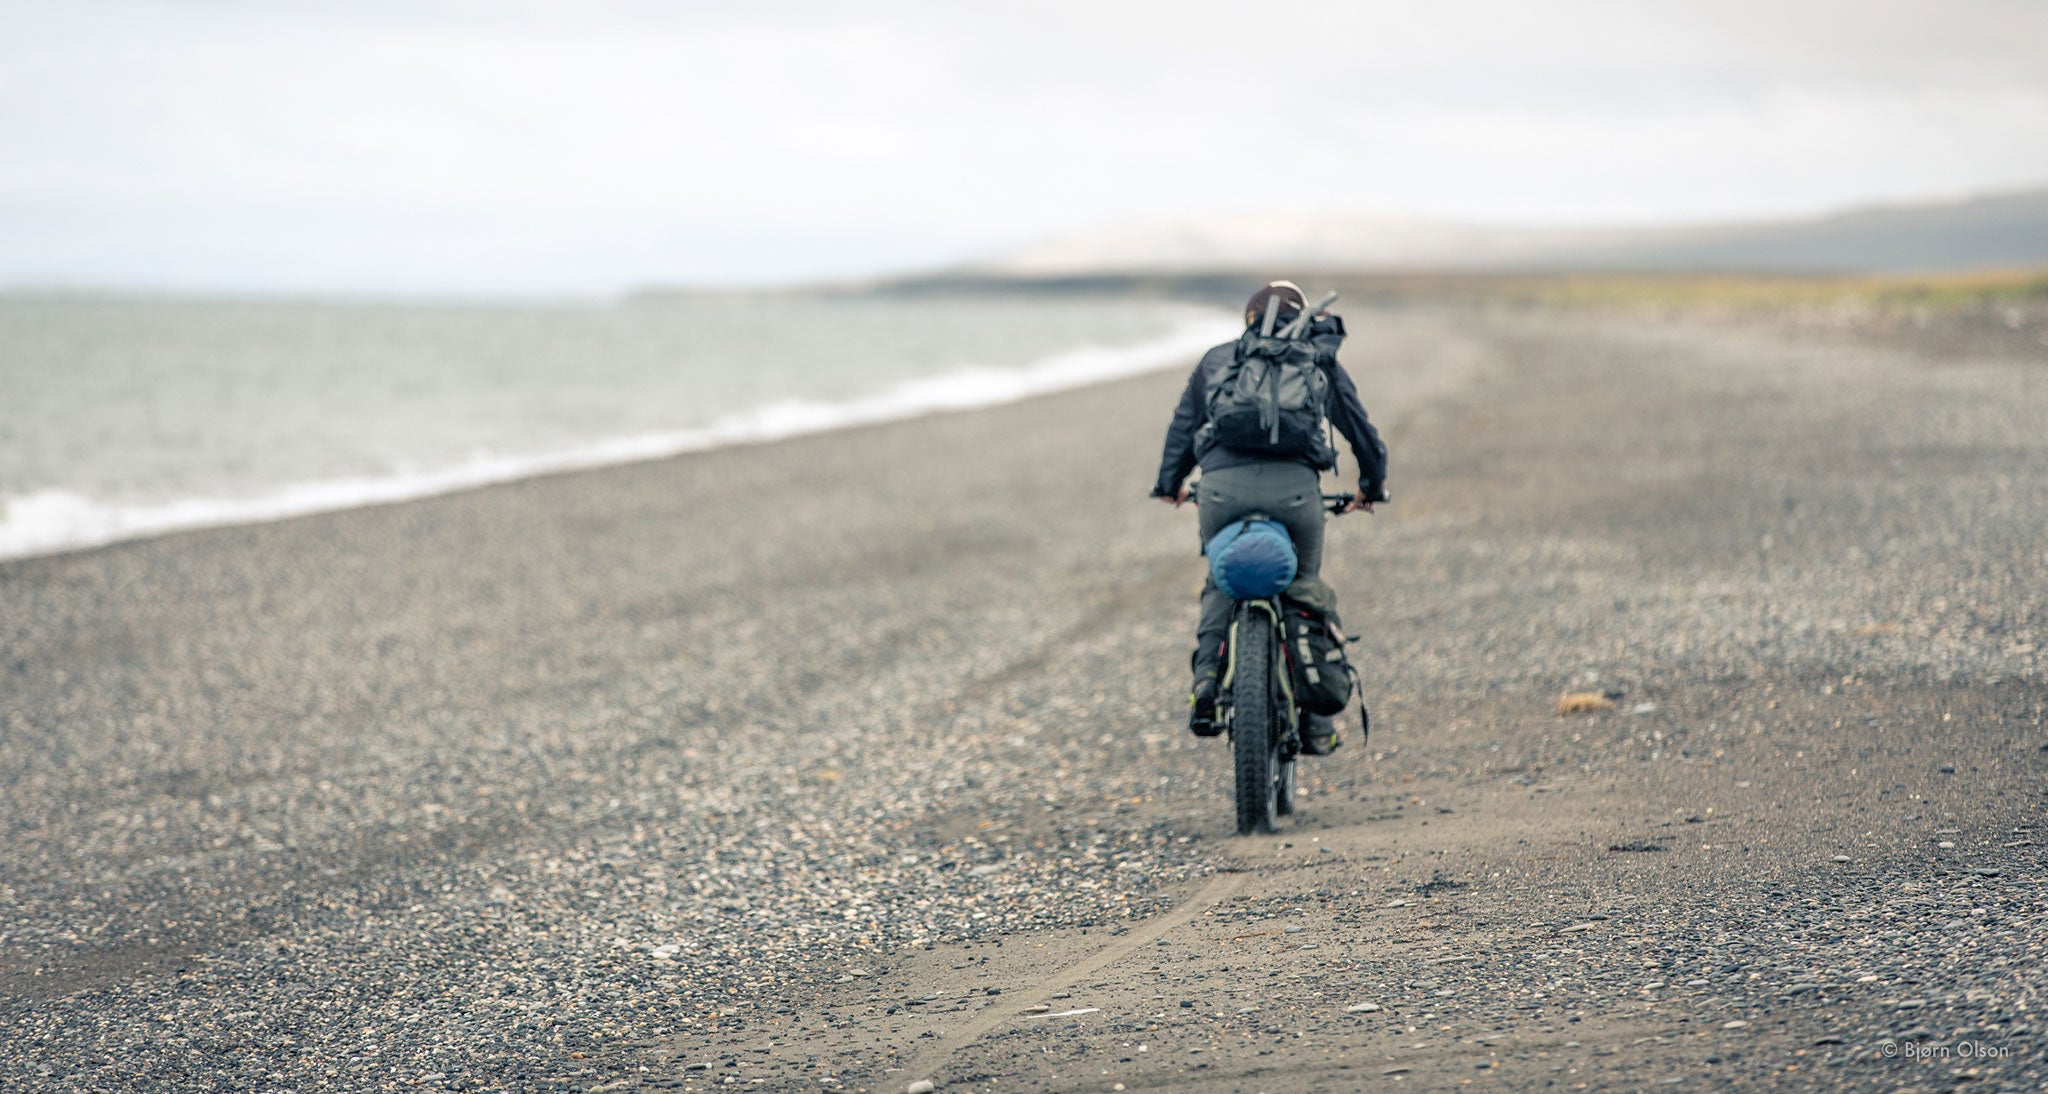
[{"x1": 961, "y1": 188, "x2": 2048, "y2": 279}]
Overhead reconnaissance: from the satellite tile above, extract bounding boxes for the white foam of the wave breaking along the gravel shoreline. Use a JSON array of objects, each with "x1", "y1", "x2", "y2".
[{"x1": 0, "y1": 313, "x2": 1235, "y2": 559}]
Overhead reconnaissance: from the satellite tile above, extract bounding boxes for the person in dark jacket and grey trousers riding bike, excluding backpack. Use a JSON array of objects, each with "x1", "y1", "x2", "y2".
[{"x1": 1151, "y1": 281, "x2": 1386, "y2": 752}]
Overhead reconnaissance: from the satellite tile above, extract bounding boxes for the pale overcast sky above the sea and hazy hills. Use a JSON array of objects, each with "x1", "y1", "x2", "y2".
[{"x1": 0, "y1": 0, "x2": 2048, "y2": 293}]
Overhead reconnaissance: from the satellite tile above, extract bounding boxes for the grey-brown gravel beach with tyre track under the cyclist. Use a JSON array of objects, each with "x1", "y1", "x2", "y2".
[{"x1": 0, "y1": 307, "x2": 2048, "y2": 1092}]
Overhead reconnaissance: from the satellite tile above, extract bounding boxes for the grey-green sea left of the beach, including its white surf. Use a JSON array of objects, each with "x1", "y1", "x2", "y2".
[{"x1": 0, "y1": 293, "x2": 1235, "y2": 557}]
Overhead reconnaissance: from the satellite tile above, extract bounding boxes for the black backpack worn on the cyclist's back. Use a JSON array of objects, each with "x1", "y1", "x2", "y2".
[{"x1": 1204, "y1": 330, "x2": 1329, "y2": 459}]
